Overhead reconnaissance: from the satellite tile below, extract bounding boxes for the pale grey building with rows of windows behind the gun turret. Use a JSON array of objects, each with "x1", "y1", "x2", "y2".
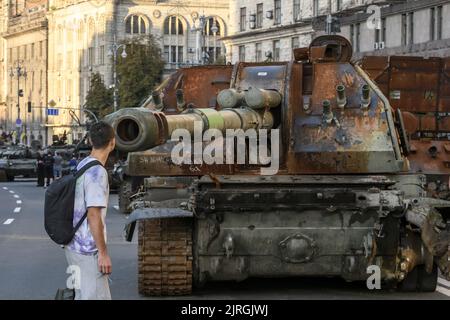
[{"x1": 223, "y1": 0, "x2": 450, "y2": 63}]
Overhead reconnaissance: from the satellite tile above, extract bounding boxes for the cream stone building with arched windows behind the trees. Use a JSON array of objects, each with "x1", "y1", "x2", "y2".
[{"x1": 47, "y1": 0, "x2": 229, "y2": 141}]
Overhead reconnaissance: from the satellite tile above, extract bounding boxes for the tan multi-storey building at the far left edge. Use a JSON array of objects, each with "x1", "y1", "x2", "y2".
[{"x1": 1, "y1": 0, "x2": 47, "y2": 144}]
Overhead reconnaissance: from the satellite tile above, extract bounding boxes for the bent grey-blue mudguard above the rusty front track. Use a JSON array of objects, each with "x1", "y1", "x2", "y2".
[{"x1": 124, "y1": 208, "x2": 194, "y2": 242}]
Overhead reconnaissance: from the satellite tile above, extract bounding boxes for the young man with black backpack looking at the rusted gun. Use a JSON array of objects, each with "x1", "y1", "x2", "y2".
[{"x1": 45, "y1": 121, "x2": 115, "y2": 300}]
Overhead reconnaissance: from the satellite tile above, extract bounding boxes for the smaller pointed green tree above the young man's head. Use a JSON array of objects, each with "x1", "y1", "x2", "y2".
[{"x1": 85, "y1": 72, "x2": 113, "y2": 118}]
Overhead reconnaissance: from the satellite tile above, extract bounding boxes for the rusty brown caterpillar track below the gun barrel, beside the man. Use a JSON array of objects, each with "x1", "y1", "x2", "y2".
[{"x1": 138, "y1": 218, "x2": 192, "y2": 296}]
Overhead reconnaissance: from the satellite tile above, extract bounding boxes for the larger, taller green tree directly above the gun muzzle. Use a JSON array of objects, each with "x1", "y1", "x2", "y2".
[{"x1": 117, "y1": 35, "x2": 164, "y2": 108}]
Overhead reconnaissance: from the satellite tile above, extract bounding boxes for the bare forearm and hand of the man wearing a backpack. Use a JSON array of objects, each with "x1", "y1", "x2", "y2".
[{"x1": 87, "y1": 207, "x2": 112, "y2": 274}]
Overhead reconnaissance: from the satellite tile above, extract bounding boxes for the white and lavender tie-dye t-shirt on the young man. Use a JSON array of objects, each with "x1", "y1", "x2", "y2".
[{"x1": 68, "y1": 157, "x2": 109, "y2": 255}]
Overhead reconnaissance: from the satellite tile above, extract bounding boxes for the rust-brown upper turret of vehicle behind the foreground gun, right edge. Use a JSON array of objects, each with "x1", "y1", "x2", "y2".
[{"x1": 361, "y1": 56, "x2": 450, "y2": 140}]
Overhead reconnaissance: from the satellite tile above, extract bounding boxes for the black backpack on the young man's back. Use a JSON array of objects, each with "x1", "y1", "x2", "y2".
[{"x1": 44, "y1": 160, "x2": 102, "y2": 245}]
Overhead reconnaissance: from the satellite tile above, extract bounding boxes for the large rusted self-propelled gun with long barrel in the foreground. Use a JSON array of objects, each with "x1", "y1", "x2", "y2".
[{"x1": 106, "y1": 36, "x2": 450, "y2": 295}]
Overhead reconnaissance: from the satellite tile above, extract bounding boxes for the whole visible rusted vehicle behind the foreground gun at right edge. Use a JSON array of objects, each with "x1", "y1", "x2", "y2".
[{"x1": 362, "y1": 56, "x2": 450, "y2": 198}]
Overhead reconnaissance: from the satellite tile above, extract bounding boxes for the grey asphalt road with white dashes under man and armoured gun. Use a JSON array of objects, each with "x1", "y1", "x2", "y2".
[{"x1": 0, "y1": 179, "x2": 450, "y2": 300}]
